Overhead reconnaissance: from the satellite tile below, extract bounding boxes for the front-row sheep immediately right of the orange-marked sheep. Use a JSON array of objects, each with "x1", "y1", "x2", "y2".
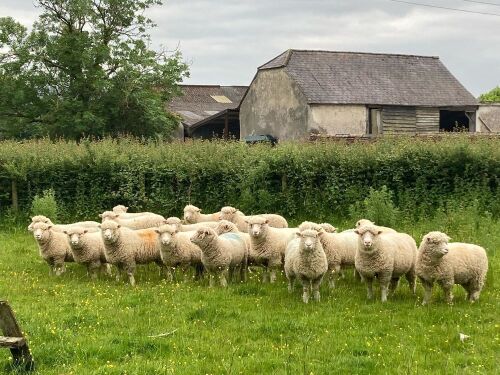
[{"x1": 155, "y1": 225, "x2": 203, "y2": 281}]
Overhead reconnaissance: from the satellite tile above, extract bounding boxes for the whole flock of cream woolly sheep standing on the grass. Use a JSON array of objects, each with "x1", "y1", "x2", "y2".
[{"x1": 28, "y1": 205, "x2": 488, "y2": 304}]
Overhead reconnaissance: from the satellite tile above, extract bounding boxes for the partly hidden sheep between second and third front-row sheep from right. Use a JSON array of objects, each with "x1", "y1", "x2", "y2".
[{"x1": 299, "y1": 221, "x2": 360, "y2": 289}]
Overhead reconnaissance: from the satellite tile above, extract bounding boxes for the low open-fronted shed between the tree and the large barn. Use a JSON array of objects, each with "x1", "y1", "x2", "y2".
[{"x1": 167, "y1": 85, "x2": 247, "y2": 138}]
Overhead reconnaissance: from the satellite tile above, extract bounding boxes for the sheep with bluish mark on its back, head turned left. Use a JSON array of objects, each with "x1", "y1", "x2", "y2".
[{"x1": 191, "y1": 227, "x2": 248, "y2": 287}]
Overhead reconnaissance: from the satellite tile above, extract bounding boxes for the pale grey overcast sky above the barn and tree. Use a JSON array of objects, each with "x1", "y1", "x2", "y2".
[{"x1": 0, "y1": 0, "x2": 500, "y2": 96}]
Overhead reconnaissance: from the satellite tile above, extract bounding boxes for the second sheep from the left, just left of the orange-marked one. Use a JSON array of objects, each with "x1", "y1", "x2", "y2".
[{"x1": 64, "y1": 227, "x2": 111, "y2": 279}]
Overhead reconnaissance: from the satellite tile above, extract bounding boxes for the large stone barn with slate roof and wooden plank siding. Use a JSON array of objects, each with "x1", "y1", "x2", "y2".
[{"x1": 240, "y1": 50, "x2": 478, "y2": 140}]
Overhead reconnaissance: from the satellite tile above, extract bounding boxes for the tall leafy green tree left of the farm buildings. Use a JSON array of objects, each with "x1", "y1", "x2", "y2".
[{"x1": 0, "y1": 0, "x2": 189, "y2": 138}]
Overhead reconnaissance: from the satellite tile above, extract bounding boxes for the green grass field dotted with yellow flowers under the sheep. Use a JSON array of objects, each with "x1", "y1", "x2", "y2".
[{"x1": 0, "y1": 214, "x2": 500, "y2": 375}]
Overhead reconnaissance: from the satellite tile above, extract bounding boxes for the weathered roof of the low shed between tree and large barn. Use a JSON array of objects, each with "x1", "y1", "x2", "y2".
[{"x1": 167, "y1": 85, "x2": 247, "y2": 127}]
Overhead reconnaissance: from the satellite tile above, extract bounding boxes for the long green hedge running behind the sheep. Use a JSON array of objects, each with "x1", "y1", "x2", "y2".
[{"x1": 0, "y1": 135, "x2": 500, "y2": 220}]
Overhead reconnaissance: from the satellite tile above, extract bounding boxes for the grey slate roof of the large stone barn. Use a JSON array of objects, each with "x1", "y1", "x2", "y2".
[{"x1": 258, "y1": 50, "x2": 477, "y2": 107}]
